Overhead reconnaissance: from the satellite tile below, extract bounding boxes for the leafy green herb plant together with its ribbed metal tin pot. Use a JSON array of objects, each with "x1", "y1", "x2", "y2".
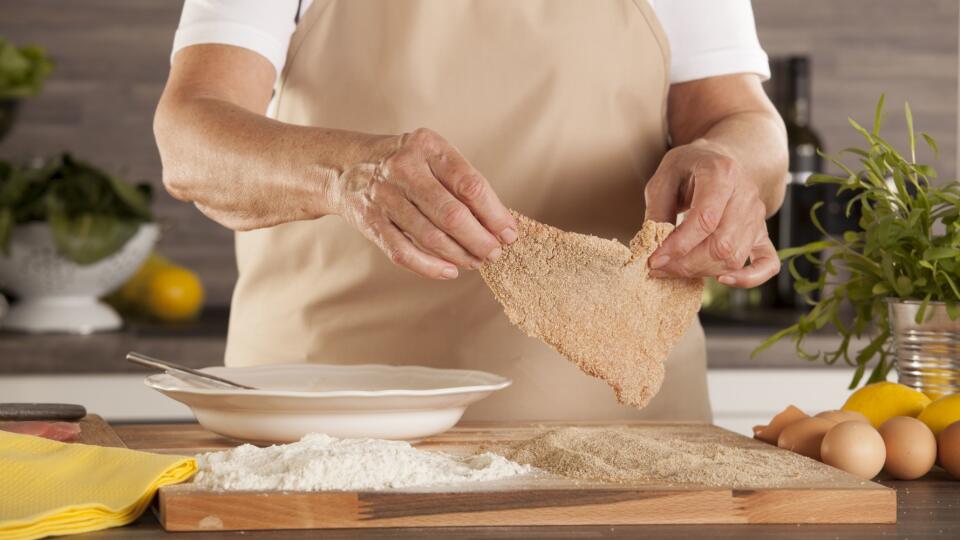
[{"x1": 754, "y1": 96, "x2": 960, "y2": 397}]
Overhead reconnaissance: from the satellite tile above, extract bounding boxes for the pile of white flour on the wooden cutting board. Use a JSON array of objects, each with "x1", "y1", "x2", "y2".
[{"x1": 193, "y1": 433, "x2": 533, "y2": 491}]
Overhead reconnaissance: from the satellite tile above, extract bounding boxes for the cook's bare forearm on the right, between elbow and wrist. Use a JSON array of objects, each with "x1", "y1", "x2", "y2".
[{"x1": 688, "y1": 111, "x2": 788, "y2": 216}]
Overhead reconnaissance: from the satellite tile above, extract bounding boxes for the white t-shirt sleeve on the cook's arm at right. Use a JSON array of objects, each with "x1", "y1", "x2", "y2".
[{"x1": 650, "y1": 0, "x2": 770, "y2": 83}]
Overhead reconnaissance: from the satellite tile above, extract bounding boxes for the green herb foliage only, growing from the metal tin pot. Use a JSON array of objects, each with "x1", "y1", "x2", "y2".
[{"x1": 753, "y1": 96, "x2": 960, "y2": 388}]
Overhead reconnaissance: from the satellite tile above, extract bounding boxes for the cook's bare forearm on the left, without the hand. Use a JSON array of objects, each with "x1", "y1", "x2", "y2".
[{"x1": 154, "y1": 95, "x2": 396, "y2": 230}]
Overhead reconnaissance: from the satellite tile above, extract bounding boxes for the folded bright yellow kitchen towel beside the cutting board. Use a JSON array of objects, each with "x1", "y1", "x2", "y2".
[{"x1": 0, "y1": 431, "x2": 197, "y2": 540}]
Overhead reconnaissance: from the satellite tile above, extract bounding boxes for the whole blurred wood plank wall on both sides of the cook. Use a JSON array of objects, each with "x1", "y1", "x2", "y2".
[{"x1": 0, "y1": 0, "x2": 960, "y2": 304}]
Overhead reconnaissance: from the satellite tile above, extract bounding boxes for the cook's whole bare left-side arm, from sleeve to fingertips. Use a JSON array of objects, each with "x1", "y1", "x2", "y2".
[{"x1": 154, "y1": 44, "x2": 517, "y2": 279}]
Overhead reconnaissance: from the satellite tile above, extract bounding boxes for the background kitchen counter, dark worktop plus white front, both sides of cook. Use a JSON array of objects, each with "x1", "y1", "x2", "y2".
[{"x1": 0, "y1": 307, "x2": 868, "y2": 433}]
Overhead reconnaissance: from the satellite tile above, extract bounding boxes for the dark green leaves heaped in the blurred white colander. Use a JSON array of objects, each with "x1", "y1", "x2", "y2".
[{"x1": 0, "y1": 154, "x2": 153, "y2": 264}]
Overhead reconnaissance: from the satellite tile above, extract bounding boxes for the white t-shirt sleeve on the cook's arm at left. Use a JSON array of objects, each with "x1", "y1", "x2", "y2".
[{"x1": 172, "y1": 0, "x2": 308, "y2": 76}]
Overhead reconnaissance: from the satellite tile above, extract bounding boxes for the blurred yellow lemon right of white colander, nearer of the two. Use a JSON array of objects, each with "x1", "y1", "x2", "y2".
[{"x1": 142, "y1": 265, "x2": 203, "y2": 321}]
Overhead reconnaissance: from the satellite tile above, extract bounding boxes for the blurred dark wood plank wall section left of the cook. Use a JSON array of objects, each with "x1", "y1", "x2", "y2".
[{"x1": 0, "y1": 0, "x2": 236, "y2": 304}]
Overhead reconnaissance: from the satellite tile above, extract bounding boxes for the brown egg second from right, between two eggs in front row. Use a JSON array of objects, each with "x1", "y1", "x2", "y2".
[{"x1": 879, "y1": 416, "x2": 937, "y2": 480}]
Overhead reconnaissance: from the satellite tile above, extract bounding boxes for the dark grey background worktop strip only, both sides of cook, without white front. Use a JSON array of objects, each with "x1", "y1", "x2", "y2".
[{"x1": 0, "y1": 307, "x2": 856, "y2": 376}]
